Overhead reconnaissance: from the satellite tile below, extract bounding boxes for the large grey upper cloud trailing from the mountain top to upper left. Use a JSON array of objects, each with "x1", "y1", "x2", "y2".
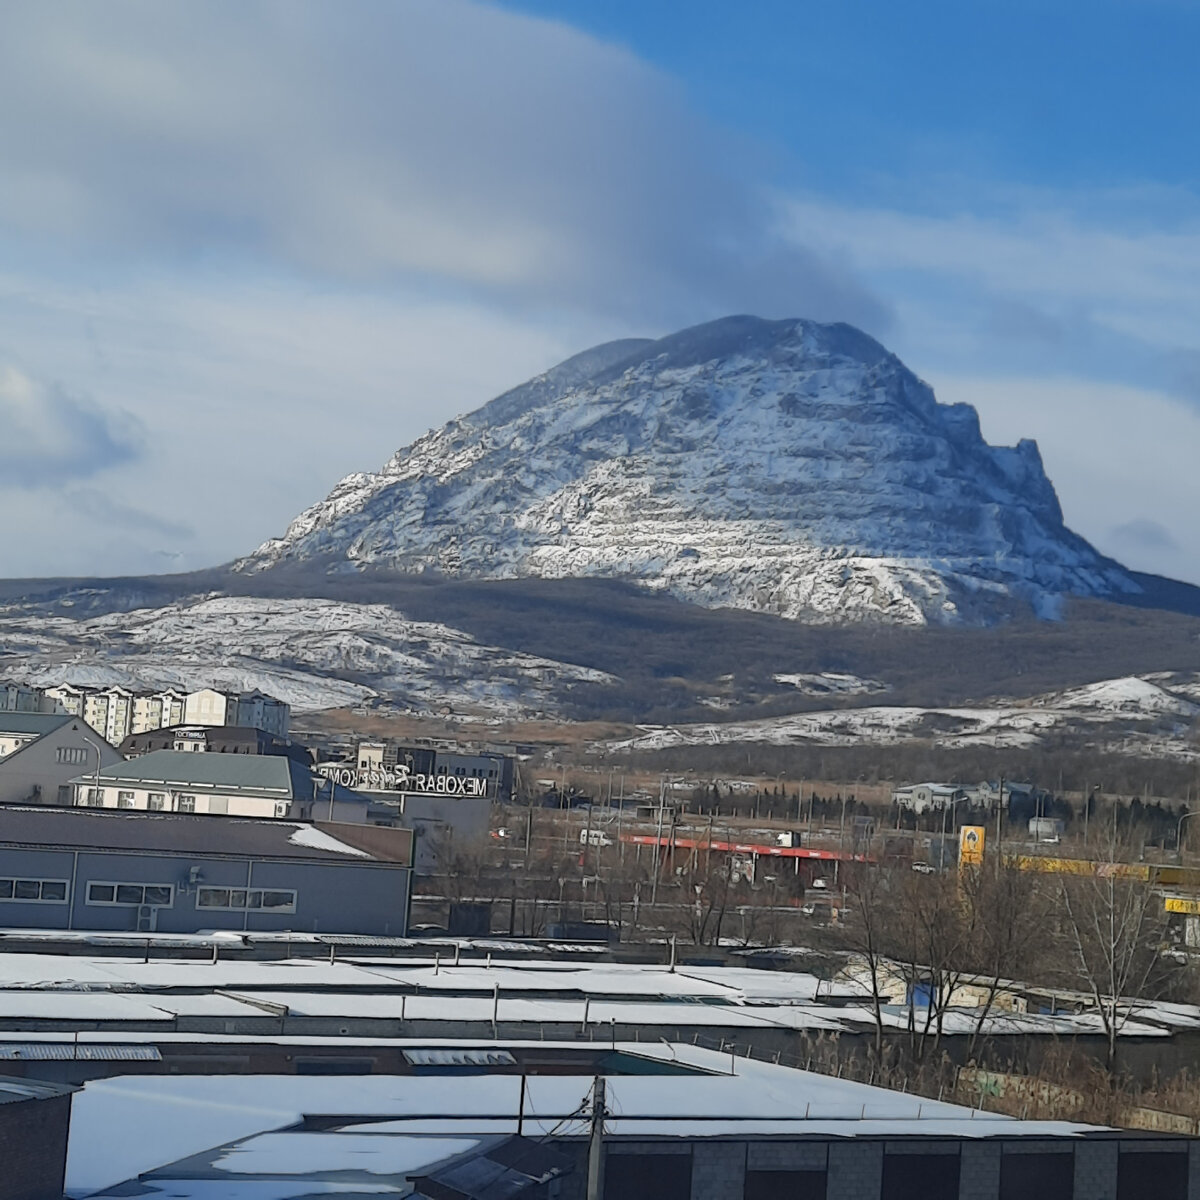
[{"x1": 0, "y1": 0, "x2": 883, "y2": 325}]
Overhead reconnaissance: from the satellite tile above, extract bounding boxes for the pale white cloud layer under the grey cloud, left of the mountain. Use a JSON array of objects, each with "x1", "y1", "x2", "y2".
[{"x1": 0, "y1": 275, "x2": 585, "y2": 576}]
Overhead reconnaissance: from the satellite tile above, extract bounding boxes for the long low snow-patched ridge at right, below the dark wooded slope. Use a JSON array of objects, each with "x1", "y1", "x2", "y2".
[{"x1": 604, "y1": 676, "x2": 1200, "y2": 758}]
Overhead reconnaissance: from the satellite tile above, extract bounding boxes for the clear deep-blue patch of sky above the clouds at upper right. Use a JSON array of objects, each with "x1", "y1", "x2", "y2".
[{"x1": 509, "y1": 0, "x2": 1200, "y2": 199}]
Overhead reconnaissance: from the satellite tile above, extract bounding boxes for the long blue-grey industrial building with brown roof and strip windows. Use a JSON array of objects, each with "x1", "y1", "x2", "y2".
[{"x1": 0, "y1": 806, "x2": 412, "y2": 936}]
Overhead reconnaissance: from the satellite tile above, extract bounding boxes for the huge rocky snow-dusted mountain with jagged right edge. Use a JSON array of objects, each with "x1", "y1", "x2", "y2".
[{"x1": 236, "y1": 317, "x2": 1140, "y2": 624}]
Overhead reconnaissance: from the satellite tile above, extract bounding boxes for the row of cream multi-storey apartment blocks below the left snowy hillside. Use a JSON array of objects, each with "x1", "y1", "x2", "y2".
[{"x1": 46, "y1": 683, "x2": 290, "y2": 745}]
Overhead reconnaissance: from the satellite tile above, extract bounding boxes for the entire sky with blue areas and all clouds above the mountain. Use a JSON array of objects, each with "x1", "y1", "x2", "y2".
[{"x1": 0, "y1": 0, "x2": 1200, "y2": 582}]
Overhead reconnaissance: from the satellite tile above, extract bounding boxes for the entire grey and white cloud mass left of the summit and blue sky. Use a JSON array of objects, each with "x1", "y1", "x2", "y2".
[{"x1": 0, "y1": 0, "x2": 886, "y2": 575}]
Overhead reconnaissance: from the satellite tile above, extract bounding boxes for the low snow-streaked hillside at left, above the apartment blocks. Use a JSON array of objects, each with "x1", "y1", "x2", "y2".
[{"x1": 0, "y1": 596, "x2": 610, "y2": 718}]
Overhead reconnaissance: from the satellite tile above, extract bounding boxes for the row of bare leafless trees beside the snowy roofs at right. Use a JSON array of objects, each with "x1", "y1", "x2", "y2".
[{"x1": 845, "y1": 825, "x2": 1176, "y2": 1067}]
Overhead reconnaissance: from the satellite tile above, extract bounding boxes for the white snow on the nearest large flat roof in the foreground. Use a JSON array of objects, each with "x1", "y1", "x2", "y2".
[{"x1": 67, "y1": 1043, "x2": 1108, "y2": 1196}]
